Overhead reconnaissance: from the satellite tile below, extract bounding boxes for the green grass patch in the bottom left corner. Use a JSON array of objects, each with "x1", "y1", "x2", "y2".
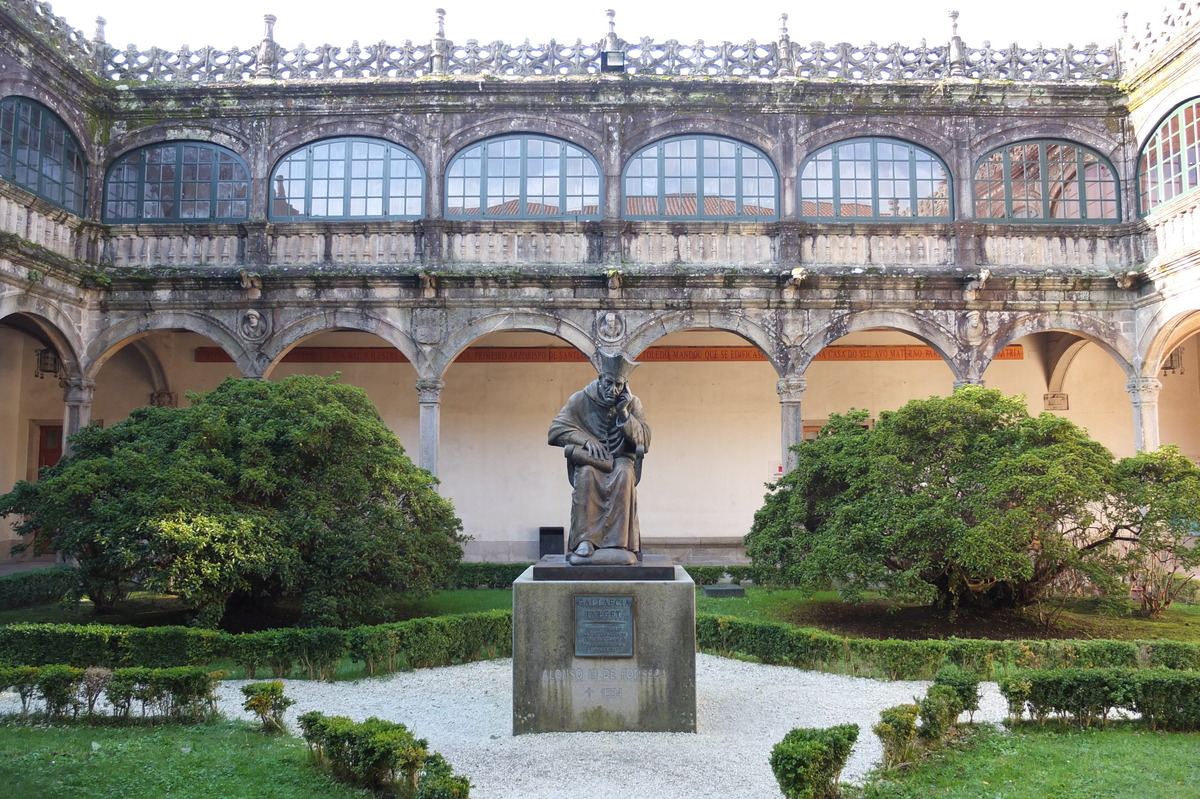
[{"x1": 0, "y1": 721, "x2": 371, "y2": 799}]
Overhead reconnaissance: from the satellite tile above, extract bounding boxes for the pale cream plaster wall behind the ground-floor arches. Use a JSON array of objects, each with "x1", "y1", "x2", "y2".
[{"x1": 0, "y1": 321, "x2": 1200, "y2": 560}]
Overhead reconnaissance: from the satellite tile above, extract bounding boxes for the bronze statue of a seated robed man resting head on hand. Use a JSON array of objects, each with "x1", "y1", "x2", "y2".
[{"x1": 550, "y1": 353, "x2": 650, "y2": 565}]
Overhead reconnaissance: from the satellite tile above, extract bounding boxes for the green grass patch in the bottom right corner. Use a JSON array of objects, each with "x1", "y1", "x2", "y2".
[{"x1": 847, "y1": 725, "x2": 1200, "y2": 799}]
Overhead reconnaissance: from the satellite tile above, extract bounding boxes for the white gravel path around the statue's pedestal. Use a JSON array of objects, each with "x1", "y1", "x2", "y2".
[{"x1": 211, "y1": 654, "x2": 1004, "y2": 799}]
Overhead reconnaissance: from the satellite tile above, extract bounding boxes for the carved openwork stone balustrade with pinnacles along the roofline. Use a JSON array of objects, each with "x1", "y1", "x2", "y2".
[{"x1": 6, "y1": 0, "x2": 1123, "y2": 84}]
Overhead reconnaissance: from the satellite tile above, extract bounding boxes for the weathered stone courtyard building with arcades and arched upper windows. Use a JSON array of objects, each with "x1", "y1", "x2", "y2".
[{"x1": 0, "y1": 0, "x2": 1200, "y2": 563}]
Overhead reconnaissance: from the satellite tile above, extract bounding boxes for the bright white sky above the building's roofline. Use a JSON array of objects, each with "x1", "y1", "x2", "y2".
[{"x1": 37, "y1": 0, "x2": 1162, "y2": 49}]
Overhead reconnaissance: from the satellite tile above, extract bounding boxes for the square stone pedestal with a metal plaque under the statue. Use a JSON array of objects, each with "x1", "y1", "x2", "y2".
[{"x1": 512, "y1": 566, "x2": 696, "y2": 735}]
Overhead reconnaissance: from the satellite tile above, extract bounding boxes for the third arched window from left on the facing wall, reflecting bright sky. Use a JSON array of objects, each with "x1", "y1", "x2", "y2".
[{"x1": 446, "y1": 134, "x2": 600, "y2": 220}]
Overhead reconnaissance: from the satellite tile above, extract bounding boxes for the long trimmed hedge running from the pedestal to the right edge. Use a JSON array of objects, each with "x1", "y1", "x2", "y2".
[{"x1": 696, "y1": 614, "x2": 1200, "y2": 679}]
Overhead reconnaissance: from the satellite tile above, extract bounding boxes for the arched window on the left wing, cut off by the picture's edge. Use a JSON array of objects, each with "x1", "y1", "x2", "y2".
[{"x1": 0, "y1": 96, "x2": 88, "y2": 216}]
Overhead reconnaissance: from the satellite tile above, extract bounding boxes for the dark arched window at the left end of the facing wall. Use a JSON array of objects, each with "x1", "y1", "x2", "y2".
[{"x1": 104, "y1": 142, "x2": 250, "y2": 223}]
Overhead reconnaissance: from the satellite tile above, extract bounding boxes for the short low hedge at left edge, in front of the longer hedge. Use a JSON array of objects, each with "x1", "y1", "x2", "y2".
[{"x1": 0, "y1": 663, "x2": 224, "y2": 721}]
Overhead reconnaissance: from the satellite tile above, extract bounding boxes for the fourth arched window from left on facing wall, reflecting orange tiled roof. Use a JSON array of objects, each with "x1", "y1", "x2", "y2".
[{"x1": 624, "y1": 136, "x2": 779, "y2": 220}]
